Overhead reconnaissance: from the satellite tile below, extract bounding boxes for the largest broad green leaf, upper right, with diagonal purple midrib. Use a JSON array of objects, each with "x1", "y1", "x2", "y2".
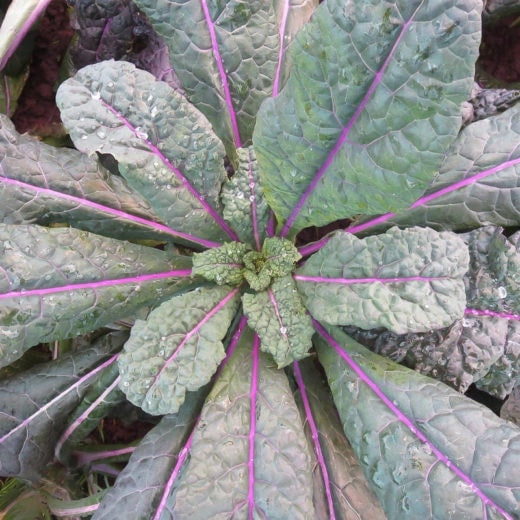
[{"x1": 253, "y1": 0, "x2": 481, "y2": 236}]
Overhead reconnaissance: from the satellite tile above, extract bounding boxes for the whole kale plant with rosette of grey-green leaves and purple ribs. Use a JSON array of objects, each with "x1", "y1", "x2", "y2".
[{"x1": 0, "y1": 0, "x2": 520, "y2": 520}]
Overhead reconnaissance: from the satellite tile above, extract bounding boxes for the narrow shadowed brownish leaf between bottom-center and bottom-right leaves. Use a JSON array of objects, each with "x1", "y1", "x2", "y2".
[{"x1": 293, "y1": 359, "x2": 386, "y2": 520}]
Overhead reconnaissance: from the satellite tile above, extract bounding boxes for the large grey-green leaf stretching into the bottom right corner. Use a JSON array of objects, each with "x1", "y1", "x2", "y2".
[{"x1": 316, "y1": 323, "x2": 520, "y2": 520}]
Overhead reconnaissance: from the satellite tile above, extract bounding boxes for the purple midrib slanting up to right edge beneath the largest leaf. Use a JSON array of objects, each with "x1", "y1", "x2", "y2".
[{"x1": 298, "y1": 157, "x2": 520, "y2": 256}]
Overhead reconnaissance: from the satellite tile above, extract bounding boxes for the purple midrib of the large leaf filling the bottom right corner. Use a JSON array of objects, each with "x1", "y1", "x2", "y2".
[{"x1": 312, "y1": 319, "x2": 513, "y2": 520}]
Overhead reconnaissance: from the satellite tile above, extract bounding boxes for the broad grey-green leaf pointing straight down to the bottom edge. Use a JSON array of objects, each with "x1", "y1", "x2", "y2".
[{"x1": 169, "y1": 330, "x2": 313, "y2": 519}]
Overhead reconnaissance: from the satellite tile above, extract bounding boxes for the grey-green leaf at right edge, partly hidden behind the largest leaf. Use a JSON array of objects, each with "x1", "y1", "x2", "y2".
[{"x1": 352, "y1": 104, "x2": 520, "y2": 232}]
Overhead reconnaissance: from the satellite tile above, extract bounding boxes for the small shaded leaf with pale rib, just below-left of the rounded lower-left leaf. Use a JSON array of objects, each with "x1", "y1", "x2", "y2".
[{"x1": 54, "y1": 363, "x2": 124, "y2": 465}]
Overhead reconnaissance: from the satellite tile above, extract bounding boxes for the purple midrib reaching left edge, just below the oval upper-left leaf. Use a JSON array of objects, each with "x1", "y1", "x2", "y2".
[{"x1": 0, "y1": 176, "x2": 221, "y2": 248}]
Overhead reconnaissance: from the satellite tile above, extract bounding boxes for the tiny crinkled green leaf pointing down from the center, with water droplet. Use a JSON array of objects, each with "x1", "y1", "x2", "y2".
[{"x1": 242, "y1": 276, "x2": 314, "y2": 368}]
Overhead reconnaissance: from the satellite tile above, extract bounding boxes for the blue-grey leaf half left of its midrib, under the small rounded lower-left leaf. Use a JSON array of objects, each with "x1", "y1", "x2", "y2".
[{"x1": 92, "y1": 391, "x2": 206, "y2": 520}]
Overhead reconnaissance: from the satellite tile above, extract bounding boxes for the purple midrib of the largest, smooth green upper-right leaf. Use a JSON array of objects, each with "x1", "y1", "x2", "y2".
[{"x1": 280, "y1": 8, "x2": 418, "y2": 237}]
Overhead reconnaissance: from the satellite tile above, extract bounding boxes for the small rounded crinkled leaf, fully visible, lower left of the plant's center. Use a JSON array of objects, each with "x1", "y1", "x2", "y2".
[{"x1": 119, "y1": 286, "x2": 239, "y2": 415}]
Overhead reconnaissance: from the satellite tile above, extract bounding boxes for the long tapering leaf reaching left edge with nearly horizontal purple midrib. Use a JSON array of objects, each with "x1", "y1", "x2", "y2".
[{"x1": 0, "y1": 224, "x2": 193, "y2": 366}]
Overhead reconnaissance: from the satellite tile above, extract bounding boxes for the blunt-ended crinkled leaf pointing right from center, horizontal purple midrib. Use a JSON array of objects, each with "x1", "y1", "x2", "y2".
[{"x1": 294, "y1": 228, "x2": 468, "y2": 333}]
